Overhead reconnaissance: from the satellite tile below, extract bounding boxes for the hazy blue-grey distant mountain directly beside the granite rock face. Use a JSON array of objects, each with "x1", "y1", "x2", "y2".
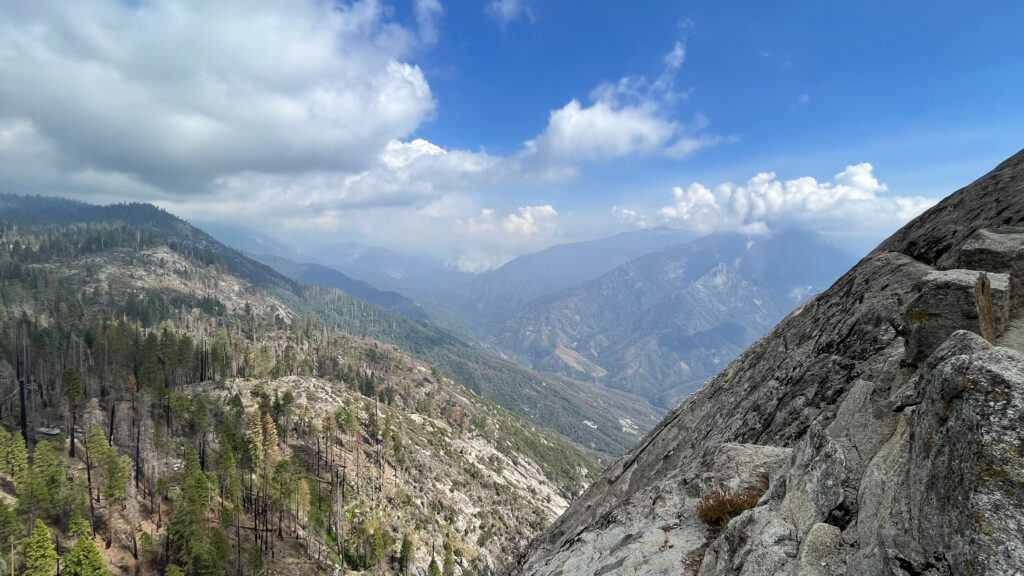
[{"x1": 492, "y1": 226, "x2": 853, "y2": 407}]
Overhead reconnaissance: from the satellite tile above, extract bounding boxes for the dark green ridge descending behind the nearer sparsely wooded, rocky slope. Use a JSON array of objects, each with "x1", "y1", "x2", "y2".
[{"x1": 0, "y1": 195, "x2": 659, "y2": 456}]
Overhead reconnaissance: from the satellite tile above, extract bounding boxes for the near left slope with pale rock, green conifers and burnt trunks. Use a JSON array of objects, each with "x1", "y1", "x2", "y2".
[{"x1": 0, "y1": 218, "x2": 599, "y2": 575}]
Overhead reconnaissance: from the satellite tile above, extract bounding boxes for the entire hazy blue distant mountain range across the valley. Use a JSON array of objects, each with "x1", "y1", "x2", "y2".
[{"x1": 218, "y1": 217, "x2": 855, "y2": 409}]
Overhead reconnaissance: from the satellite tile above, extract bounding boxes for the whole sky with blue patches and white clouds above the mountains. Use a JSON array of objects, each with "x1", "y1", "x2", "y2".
[{"x1": 0, "y1": 0, "x2": 1024, "y2": 270}]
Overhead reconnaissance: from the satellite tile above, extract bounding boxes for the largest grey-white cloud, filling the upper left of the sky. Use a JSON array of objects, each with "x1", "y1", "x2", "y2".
[{"x1": 0, "y1": 0, "x2": 440, "y2": 195}]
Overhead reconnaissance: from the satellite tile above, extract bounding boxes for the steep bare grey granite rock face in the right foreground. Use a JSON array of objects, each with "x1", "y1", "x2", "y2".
[{"x1": 509, "y1": 147, "x2": 1024, "y2": 576}]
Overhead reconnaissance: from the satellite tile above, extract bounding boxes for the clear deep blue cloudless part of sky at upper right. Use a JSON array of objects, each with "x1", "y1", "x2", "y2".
[{"x1": 417, "y1": 1, "x2": 1024, "y2": 195}]
